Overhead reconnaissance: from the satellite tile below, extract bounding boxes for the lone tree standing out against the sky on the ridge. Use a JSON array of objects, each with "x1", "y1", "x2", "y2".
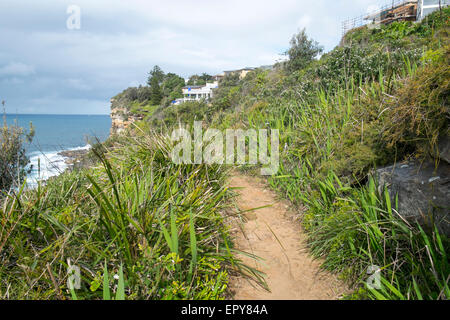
[{"x1": 285, "y1": 29, "x2": 323, "y2": 71}]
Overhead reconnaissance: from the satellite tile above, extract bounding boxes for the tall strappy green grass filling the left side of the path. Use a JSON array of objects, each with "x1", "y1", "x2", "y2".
[{"x1": 0, "y1": 128, "x2": 245, "y2": 299}]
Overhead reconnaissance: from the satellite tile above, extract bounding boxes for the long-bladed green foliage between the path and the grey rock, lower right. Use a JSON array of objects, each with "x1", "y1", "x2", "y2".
[{"x1": 303, "y1": 175, "x2": 450, "y2": 300}]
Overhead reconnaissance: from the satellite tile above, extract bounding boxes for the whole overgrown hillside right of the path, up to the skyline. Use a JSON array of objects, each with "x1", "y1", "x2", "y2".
[{"x1": 149, "y1": 8, "x2": 450, "y2": 299}]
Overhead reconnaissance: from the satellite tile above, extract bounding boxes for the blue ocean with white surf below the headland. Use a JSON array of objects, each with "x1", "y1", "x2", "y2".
[{"x1": 6, "y1": 114, "x2": 111, "y2": 187}]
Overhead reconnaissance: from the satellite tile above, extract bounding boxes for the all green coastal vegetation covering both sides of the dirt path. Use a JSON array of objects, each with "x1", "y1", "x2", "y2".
[{"x1": 0, "y1": 8, "x2": 450, "y2": 299}]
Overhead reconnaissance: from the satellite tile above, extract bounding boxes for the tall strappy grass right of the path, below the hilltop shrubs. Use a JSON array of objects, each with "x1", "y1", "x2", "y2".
[{"x1": 222, "y1": 51, "x2": 450, "y2": 299}]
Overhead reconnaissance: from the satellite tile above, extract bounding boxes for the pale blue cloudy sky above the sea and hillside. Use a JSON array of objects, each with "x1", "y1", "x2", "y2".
[{"x1": 0, "y1": 0, "x2": 389, "y2": 114}]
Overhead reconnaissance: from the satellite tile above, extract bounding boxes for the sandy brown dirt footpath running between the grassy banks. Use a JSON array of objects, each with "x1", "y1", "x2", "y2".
[{"x1": 230, "y1": 173, "x2": 346, "y2": 300}]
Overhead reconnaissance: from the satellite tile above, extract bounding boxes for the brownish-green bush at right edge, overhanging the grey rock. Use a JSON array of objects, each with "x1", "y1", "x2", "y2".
[{"x1": 384, "y1": 46, "x2": 450, "y2": 158}]
